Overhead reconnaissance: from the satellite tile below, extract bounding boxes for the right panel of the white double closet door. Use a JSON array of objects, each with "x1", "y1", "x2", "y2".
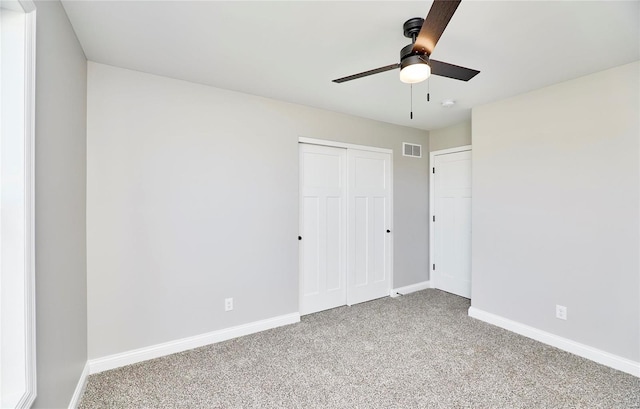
[{"x1": 347, "y1": 149, "x2": 391, "y2": 305}]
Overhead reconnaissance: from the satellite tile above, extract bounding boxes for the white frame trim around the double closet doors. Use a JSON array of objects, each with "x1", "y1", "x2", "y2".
[{"x1": 297, "y1": 136, "x2": 394, "y2": 310}]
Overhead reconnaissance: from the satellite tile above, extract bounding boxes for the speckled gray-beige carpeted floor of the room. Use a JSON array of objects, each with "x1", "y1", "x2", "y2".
[{"x1": 80, "y1": 290, "x2": 640, "y2": 409}]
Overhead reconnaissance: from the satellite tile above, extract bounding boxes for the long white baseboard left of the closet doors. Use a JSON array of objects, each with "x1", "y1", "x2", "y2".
[{"x1": 89, "y1": 312, "x2": 300, "y2": 374}]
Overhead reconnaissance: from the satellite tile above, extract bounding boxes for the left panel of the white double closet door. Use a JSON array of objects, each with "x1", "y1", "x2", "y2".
[{"x1": 299, "y1": 144, "x2": 347, "y2": 314}]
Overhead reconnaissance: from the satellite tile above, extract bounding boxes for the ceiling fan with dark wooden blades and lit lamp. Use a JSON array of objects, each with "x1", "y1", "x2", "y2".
[{"x1": 333, "y1": 0, "x2": 480, "y2": 84}]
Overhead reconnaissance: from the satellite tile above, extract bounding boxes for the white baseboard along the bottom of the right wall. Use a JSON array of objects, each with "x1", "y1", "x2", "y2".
[{"x1": 469, "y1": 307, "x2": 640, "y2": 377}]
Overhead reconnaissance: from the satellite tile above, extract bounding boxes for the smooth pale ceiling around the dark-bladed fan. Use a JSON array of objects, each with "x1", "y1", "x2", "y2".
[{"x1": 63, "y1": 0, "x2": 640, "y2": 130}]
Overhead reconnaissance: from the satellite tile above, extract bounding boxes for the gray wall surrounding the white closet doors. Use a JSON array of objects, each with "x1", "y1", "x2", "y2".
[{"x1": 87, "y1": 63, "x2": 428, "y2": 358}]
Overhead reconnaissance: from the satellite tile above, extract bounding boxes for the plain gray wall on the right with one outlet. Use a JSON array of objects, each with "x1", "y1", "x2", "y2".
[{"x1": 472, "y1": 62, "x2": 640, "y2": 362}]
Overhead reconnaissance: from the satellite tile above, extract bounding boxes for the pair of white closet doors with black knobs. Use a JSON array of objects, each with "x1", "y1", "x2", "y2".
[{"x1": 299, "y1": 144, "x2": 391, "y2": 314}]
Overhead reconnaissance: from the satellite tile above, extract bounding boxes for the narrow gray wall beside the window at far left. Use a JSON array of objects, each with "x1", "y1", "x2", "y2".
[{"x1": 34, "y1": 1, "x2": 87, "y2": 408}]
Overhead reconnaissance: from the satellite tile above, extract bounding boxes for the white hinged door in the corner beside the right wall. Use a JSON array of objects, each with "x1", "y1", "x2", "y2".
[{"x1": 432, "y1": 149, "x2": 471, "y2": 298}]
